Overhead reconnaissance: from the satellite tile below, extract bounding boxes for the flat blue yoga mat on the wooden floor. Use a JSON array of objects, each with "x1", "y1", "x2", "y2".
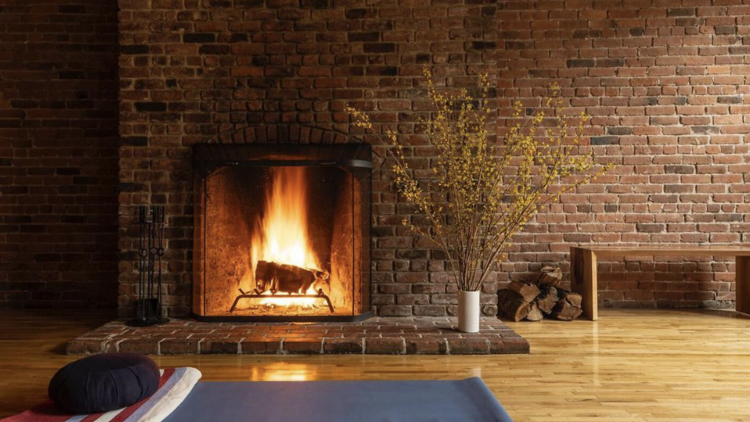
[{"x1": 165, "y1": 378, "x2": 513, "y2": 422}]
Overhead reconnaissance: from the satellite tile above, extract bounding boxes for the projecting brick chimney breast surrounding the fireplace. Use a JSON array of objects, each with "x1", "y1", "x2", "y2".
[{"x1": 119, "y1": 0, "x2": 497, "y2": 315}]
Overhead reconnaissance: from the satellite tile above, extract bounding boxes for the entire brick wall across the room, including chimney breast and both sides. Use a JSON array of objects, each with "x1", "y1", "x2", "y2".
[{"x1": 0, "y1": 0, "x2": 750, "y2": 315}]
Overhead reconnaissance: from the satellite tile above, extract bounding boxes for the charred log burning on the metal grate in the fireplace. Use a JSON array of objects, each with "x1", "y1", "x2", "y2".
[{"x1": 255, "y1": 261, "x2": 328, "y2": 294}]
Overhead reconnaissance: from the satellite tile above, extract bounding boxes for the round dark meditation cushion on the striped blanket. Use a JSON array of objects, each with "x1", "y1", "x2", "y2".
[{"x1": 48, "y1": 353, "x2": 160, "y2": 414}]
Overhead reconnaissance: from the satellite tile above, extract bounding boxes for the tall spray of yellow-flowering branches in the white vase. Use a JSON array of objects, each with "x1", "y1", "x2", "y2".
[{"x1": 347, "y1": 69, "x2": 610, "y2": 291}]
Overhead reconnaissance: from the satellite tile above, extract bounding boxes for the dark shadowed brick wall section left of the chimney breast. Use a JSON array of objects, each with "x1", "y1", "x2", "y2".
[{"x1": 0, "y1": 0, "x2": 118, "y2": 308}]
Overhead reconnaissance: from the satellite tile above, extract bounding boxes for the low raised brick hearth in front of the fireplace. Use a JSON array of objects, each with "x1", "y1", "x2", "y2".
[{"x1": 67, "y1": 317, "x2": 529, "y2": 355}]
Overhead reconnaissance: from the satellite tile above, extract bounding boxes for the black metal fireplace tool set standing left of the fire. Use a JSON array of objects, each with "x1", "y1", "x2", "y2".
[{"x1": 127, "y1": 205, "x2": 169, "y2": 327}]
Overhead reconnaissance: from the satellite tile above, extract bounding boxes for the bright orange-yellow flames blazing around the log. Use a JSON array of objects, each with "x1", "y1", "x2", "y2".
[{"x1": 251, "y1": 167, "x2": 321, "y2": 307}]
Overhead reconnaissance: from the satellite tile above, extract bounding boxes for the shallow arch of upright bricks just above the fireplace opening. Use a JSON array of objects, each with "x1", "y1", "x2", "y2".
[{"x1": 207, "y1": 123, "x2": 362, "y2": 144}]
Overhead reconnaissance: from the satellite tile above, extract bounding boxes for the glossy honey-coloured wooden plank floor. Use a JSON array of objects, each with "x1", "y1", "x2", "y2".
[{"x1": 0, "y1": 309, "x2": 750, "y2": 422}]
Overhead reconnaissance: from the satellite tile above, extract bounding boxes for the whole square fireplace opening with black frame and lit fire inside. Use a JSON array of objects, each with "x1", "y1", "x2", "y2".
[{"x1": 193, "y1": 144, "x2": 372, "y2": 321}]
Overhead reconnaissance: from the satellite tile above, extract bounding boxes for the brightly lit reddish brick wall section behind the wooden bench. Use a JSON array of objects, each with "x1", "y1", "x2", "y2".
[{"x1": 498, "y1": 0, "x2": 750, "y2": 307}]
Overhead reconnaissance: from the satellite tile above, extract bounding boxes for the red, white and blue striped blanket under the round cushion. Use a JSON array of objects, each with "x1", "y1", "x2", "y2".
[{"x1": 0, "y1": 368, "x2": 201, "y2": 422}]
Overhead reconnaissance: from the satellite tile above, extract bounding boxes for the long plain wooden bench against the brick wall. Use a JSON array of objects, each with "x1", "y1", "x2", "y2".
[{"x1": 570, "y1": 245, "x2": 750, "y2": 321}]
